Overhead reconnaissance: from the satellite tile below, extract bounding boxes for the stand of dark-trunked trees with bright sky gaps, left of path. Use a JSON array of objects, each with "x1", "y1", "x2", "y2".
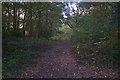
[{"x1": 2, "y1": 2, "x2": 61, "y2": 38}]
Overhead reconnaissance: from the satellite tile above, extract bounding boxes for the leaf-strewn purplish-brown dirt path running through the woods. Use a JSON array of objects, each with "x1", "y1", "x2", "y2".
[{"x1": 22, "y1": 42, "x2": 118, "y2": 78}]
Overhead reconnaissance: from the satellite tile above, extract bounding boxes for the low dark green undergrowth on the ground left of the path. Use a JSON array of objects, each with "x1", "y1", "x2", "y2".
[{"x1": 2, "y1": 38, "x2": 55, "y2": 78}]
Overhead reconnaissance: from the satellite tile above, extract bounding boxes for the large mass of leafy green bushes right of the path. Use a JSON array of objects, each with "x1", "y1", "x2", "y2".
[{"x1": 71, "y1": 4, "x2": 120, "y2": 67}]
